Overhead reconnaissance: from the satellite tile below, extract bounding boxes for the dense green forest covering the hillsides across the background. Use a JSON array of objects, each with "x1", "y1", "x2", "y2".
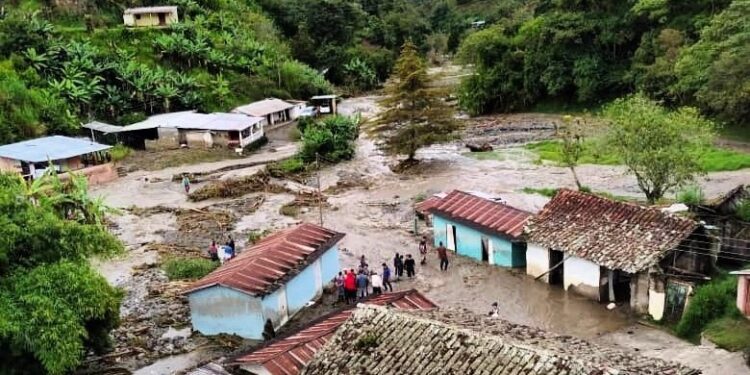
[{"x1": 0, "y1": 0, "x2": 750, "y2": 143}]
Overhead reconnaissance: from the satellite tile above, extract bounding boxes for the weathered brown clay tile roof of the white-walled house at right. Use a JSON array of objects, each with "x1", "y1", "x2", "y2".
[{"x1": 526, "y1": 189, "x2": 698, "y2": 273}]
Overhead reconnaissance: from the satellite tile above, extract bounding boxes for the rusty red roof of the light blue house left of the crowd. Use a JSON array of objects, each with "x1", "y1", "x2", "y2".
[{"x1": 184, "y1": 223, "x2": 344, "y2": 296}]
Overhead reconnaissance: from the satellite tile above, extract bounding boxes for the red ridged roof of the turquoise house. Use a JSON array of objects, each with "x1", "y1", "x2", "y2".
[{"x1": 430, "y1": 190, "x2": 531, "y2": 239}]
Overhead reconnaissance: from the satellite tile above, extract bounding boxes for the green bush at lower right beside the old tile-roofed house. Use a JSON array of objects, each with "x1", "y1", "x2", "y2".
[{"x1": 675, "y1": 275, "x2": 737, "y2": 338}]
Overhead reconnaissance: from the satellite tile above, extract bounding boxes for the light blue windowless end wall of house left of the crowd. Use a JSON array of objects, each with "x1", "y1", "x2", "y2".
[{"x1": 188, "y1": 286, "x2": 265, "y2": 339}]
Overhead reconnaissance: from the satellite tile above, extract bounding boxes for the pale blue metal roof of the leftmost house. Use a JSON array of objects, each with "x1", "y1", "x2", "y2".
[{"x1": 0, "y1": 135, "x2": 112, "y2": 163}]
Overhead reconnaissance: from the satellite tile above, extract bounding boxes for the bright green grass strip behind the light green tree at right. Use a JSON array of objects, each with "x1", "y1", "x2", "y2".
[{"x1": 525, "y1": 139, "x2": 750, "y2": 172}]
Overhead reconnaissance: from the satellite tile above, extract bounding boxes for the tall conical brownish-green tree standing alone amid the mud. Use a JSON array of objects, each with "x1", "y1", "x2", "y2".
[{"x1": 373, "y1": 42, "x2": 457, "y2": 162}]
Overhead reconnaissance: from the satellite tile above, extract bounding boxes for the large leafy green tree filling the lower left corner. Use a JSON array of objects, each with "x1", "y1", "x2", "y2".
[{"x1": 0, "y1": 173, "x2": 122, "y2": 374}]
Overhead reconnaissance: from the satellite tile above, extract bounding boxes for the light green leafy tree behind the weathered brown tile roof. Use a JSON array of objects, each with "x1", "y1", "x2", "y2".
[{"x1": 604, "y1": 94, "x2": 714, "y2": 204}]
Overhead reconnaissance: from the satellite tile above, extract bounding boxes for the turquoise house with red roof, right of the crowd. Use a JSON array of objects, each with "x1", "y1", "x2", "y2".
[{"x1": 429, "y1": 190, "x2": 531, "y2": 267}]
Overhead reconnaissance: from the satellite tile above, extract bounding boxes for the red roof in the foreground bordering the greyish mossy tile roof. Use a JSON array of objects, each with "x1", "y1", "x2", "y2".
[{"x1": 234, "y1": 289, "x2": 437, "y2": 375}]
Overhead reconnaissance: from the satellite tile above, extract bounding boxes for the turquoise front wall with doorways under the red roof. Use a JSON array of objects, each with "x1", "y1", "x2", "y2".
[{"x1": 432, "y1": 215, "x2": 526, "y2": 267}]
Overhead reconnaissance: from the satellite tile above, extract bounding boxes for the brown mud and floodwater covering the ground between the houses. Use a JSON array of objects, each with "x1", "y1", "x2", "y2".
[{"x1": 89, "y1": 97, "x2": 750, "y2": 375}]
